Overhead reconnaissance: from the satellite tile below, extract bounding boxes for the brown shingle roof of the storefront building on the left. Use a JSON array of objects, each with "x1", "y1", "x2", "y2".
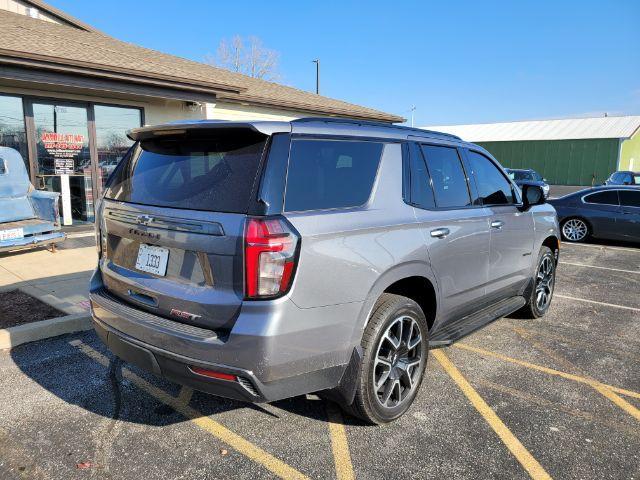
[{"x1": 0, "y1": 7, "x2": 404, "y2": 122}]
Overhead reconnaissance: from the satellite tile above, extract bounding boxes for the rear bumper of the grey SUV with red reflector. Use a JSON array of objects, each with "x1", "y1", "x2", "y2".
[{"x1": 90, "y1": 270, "x2": 355, "y2": 402}]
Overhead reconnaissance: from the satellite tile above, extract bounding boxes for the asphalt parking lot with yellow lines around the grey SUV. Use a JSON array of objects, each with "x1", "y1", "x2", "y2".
[{"x1": 0, "y1": 243, "x2": 640, "y2": 480}]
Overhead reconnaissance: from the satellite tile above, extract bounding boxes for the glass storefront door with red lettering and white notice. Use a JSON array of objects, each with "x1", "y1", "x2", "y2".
[{"x1": 31, "y1": 100, "x2": 95, "y2": 225}]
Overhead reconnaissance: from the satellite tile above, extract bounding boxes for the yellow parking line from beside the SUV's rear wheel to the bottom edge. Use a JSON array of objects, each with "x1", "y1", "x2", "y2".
[{"x1": 432, "y1": 350, "x2": 551, "y2": 479}]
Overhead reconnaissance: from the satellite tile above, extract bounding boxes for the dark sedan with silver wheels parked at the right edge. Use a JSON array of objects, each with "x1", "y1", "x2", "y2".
[{"x1": 548, "y1": 186, "x2": 640, "y2": 242}]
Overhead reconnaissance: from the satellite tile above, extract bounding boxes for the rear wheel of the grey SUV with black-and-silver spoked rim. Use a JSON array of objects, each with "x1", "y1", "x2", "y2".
[{"x1": 342, "y1": 293, "x2": 429, "y2": 424}]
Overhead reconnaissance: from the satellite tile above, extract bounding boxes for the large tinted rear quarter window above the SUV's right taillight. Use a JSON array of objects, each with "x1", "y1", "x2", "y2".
[{"x1": 285, "y1": 140, "x2": 383, "y2": 212}]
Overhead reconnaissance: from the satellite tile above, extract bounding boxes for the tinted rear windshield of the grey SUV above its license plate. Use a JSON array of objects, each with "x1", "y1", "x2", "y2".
[{"x1": 105, "y1": 130, "x2": 267, "y2": 213}]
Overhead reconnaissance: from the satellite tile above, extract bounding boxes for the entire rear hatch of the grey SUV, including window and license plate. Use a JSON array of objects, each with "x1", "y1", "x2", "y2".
[{"x1": 99, "y1": 127, "x2": 269, "y2": 331}]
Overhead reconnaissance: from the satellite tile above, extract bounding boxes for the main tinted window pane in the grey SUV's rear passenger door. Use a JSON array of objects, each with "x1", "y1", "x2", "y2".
[{"x1": 422, "y1": 145, "x2": 471, "y2": 208}]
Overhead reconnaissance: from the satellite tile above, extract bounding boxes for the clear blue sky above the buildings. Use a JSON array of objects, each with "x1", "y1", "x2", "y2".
[{"x1": 49, "y1": 0, "x2": 640, "y2": 126}]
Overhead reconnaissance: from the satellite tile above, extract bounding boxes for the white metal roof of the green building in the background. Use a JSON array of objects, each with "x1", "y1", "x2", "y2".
[{"x1": 423, "y1": 115, "x2": 640, "y2": 142}]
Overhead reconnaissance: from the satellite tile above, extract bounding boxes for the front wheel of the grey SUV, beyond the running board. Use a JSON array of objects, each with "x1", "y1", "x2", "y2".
[{"x1": 517, "y1": 247, "x2": 556, "y2": 319}]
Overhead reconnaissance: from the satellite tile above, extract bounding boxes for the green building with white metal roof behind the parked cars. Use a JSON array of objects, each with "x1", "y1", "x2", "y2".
[{"x1": 424, "y1": 115, "x2": 640, "y2": 185}]
